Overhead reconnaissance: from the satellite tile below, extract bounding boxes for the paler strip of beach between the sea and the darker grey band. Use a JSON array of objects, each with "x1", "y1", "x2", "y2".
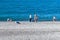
[{"x1": 0, "y1": 21, "x2": 60, "y2": 31}]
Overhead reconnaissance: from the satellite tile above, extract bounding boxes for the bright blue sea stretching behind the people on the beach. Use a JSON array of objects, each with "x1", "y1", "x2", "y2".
[{"x1": 0, "y1": 0, "x2": 60, "y2": 21}]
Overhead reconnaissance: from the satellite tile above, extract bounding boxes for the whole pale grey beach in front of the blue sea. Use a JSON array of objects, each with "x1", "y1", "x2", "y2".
[{"x1": 0, "y1": 21, "x2": 60, "y2": 40}]
